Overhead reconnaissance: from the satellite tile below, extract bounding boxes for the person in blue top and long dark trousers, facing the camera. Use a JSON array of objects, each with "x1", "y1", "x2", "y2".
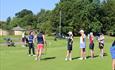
[{"x1": 28, "y1": 31, "x2": 35, "y2": 56}]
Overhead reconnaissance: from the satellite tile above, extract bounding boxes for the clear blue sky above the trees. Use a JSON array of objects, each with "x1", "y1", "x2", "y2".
[{"x1": 0, "y1": 0, "x2": 60, "y2": 21}]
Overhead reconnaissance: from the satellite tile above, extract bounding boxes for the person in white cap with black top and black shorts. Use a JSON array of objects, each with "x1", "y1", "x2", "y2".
[{"x1": 65, "y1": 32, "x2": 73, "y2": 61}]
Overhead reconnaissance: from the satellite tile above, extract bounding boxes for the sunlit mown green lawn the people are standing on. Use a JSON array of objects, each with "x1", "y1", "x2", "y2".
[{"x1": 0, "y1": 36, "x2": 115, "y2": 70}]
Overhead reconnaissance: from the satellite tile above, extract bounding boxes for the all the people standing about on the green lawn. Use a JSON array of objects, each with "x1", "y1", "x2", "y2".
[{"x1": 22, "y1": 30, "x2": 115, "y2": 70}]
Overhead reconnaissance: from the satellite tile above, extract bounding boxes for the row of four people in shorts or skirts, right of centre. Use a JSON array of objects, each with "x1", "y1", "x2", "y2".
[{"x1": 65, "y1": 30, "x2": 104, "y2": 61}]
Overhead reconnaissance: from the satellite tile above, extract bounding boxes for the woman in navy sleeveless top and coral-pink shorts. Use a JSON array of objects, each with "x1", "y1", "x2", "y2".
[{"x1": 36, "y1": 32, "x2": 45, "y2": 60}]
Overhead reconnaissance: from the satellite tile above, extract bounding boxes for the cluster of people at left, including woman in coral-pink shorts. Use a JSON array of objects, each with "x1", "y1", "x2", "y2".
[{"x1": 22, "y1": 31, "x2": 46, "y2": 60}]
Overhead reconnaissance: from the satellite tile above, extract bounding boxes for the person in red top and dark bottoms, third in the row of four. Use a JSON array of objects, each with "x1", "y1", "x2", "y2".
[{"x1": 89, "y1": 32, "x2": 94, "y2": 58}]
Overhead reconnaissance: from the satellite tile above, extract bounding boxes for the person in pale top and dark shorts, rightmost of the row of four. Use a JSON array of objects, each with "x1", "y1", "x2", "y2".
[{"x1": 98, "y1": 33, "x2": 104, "y2": 58}]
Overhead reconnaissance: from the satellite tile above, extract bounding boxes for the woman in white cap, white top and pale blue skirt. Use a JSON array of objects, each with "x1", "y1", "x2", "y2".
[{"x1": 79, "y1": 30, "x2": 86, "y2": 60}]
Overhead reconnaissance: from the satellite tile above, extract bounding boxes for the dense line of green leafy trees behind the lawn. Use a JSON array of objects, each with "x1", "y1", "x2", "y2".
[{"x1": 0, "y1": 0, "x2": 115, "y2": 35}]
